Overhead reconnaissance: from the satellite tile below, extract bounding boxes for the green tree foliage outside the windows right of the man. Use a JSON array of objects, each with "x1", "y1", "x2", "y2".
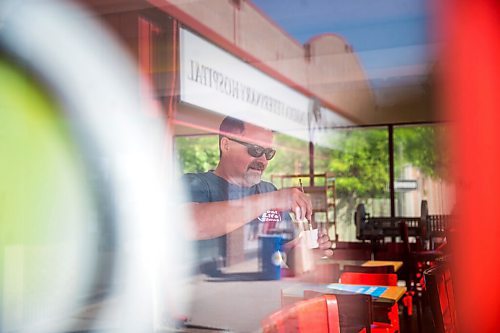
[{"x1": 316, "y1": 125, "x2": 448, "y2": 232}]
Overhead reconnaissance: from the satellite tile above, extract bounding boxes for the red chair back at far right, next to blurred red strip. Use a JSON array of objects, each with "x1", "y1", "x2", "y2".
[{"x1": 424, "y1": 266, "x2": 458, "y2": 333}]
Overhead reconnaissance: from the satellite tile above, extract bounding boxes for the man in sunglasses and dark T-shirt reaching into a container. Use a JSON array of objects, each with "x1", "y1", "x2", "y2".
[{"x1": 184, "y1": 117, "x2": 332, "y2": 255}]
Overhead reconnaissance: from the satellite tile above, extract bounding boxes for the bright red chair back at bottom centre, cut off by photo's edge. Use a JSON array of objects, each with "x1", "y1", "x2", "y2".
[{"x1": 262, "y1": 295, "x2": 340, "y2": 333}]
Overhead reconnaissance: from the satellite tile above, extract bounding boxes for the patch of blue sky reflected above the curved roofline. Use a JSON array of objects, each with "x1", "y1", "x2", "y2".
[{"x1": 252, "y1": 0, "x2": 430, "y2": 81}]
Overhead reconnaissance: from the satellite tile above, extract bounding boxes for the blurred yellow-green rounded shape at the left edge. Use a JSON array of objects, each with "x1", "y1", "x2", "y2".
[{"x1": 0, "y1": 54, "x2": 97, "y2": 331}]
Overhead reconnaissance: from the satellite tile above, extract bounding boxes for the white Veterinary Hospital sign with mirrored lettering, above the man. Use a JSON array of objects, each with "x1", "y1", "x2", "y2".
[{"x1": 176, "y1": 29, "x2": 352, "y2": 146}]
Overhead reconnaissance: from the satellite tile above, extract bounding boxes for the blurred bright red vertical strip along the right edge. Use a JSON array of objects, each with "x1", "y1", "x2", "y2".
[{"x1": 441, "y1": 0, "x2": 500, "y2": 332}]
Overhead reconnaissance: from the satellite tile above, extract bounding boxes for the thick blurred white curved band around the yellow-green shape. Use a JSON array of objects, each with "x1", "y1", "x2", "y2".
[{"x1": 0, "y1": 0, "x2": 192, "y2": 333}]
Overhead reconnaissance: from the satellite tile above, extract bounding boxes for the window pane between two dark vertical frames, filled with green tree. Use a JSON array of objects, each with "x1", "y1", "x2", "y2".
[{"x1": 315, "y1": 127, "x2": 391, "y2": 241}]
